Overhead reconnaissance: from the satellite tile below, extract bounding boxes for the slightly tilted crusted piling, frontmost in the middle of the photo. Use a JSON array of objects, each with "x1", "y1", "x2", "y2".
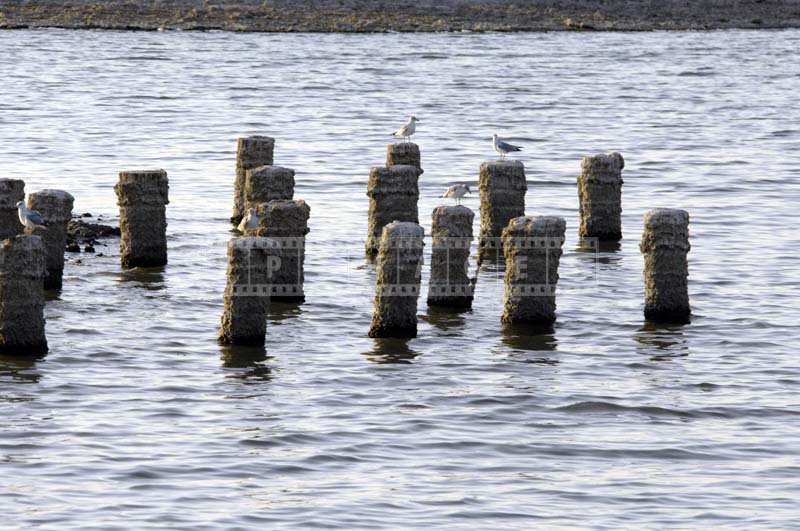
[{"x1": 369, "y1": 221, "x2": 425, "y2": 337}]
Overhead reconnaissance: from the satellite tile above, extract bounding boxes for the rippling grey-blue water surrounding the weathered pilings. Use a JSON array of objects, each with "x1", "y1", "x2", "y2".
[{"x1": 0, "y1": 30, "x2": 800, "y2": 529}]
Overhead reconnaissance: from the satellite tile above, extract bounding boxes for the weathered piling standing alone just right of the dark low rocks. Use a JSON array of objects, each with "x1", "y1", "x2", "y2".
[{"x1": 114, "y1": 170, "x2": 169, "y2": 268}]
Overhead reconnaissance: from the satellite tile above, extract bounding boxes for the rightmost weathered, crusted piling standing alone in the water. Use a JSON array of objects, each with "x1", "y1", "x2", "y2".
[{"x1": 639, "y1": 208, "x2": 691, "y2": 323}]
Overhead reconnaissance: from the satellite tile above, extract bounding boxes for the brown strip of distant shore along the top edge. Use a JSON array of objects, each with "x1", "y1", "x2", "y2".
[{"x1": 0, "y1": 0, "x2": 800, "y2": 33}]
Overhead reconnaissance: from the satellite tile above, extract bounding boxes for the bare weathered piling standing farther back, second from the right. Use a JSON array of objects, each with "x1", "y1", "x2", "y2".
[{"x1": 578, "y1": 153, "x2": 625, "y2": 241}]
